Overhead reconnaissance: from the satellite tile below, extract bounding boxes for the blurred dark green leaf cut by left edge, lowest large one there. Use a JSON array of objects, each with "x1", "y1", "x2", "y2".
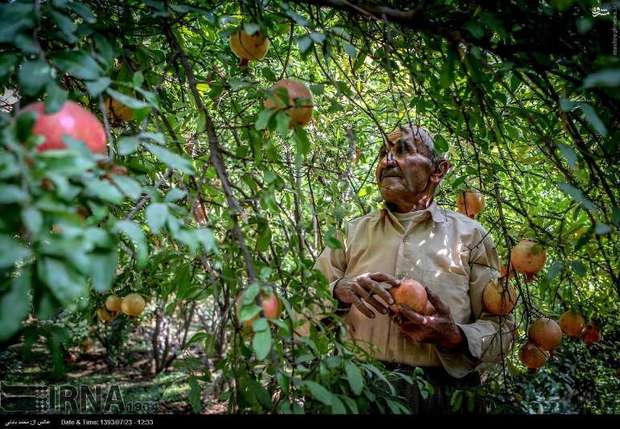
[{"x1": 0, "y1": 270, "x2": 32, "y2": 343}]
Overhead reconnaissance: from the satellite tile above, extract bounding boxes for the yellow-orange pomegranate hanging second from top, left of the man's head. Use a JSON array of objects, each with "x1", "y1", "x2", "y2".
[{"x1": 264, "y1": 79, "x2": 313, "y2": 128}]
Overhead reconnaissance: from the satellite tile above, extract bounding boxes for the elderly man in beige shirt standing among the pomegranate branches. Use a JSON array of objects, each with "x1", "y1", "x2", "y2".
[{"x1": 316, "y1": 126, "x2": 513, "y2": 413}]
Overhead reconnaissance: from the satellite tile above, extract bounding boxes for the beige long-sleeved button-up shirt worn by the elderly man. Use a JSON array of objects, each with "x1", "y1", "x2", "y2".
[{"x1": 315, "y1": 202, "x2": 514, "y2": 378}]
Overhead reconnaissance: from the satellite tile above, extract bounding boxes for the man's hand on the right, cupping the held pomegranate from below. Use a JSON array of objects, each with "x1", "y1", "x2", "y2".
[{"x1": 395, "y1": 287, "x2": 465, "y2": 350}]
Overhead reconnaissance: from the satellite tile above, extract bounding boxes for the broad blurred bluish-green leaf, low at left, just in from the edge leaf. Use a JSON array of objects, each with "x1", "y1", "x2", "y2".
[{"x1": 37, "y1": 257, "x2": 87, "y2": 305}]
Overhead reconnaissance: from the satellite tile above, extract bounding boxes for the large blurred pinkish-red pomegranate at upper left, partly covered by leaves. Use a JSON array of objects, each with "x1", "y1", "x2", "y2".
[{"x1": 24, "y1": 101, "x2": 107, "y2": 155}]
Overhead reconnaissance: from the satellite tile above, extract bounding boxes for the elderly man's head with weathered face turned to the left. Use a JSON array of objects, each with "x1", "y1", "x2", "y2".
[{"x1": 375, "y1": 128, "x2": 445, "y2": 210}]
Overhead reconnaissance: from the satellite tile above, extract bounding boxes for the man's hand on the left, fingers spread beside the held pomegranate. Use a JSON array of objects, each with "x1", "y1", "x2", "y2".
[{"x1": 334, "y1": 273, "x2": 400, "y2": 319}]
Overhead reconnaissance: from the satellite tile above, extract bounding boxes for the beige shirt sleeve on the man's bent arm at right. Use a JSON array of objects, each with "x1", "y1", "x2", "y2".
[{"x1": 438, "y1": 228, "x2": 515, "y2": 378}]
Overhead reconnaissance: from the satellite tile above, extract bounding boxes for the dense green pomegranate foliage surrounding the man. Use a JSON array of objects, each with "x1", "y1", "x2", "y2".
[{"x1": 0, "y1": 0, "x2": 620, "y2": 413}]
